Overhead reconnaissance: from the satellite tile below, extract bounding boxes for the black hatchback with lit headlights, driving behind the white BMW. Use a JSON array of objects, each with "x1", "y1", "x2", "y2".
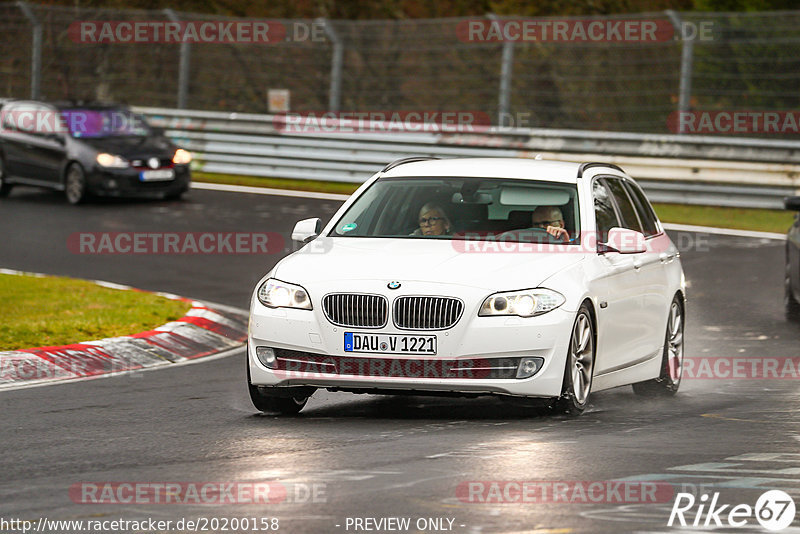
[{"x1": 0, "y1": 100, "x2": 191, "y2": 204}]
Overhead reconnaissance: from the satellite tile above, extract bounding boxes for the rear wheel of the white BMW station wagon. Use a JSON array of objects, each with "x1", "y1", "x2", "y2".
[{"x1": 633, "y1": 295, "x2": 685, "y2": 397}]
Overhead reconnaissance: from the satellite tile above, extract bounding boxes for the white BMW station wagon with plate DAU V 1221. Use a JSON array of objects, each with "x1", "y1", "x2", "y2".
[{"x1": 247, "y1": 157, "x2": 686, "y2": 414}]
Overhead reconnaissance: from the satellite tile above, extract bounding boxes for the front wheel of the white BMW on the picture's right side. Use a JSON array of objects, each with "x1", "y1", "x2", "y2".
[{"x1": 551, "y1": 304, "x2": 596, "y2": 415}]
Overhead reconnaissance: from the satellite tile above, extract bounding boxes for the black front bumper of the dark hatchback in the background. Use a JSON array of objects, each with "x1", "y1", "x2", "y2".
[{"x1": 86, "y1": 165, "x2": 191, "y2": 197}]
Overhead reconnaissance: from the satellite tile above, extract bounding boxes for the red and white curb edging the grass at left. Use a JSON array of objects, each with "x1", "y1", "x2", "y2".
[{"x1": 0, "y1": 269, "x2": 248, "y2": 390}]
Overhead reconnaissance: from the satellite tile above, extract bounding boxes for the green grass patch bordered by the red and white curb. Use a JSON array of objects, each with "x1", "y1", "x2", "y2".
[{"x1": 0, "y1": 274, "x2": 190, "y2": 350}]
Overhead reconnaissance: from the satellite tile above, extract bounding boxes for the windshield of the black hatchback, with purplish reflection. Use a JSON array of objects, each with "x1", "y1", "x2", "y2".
[{"x1": 61, "y1": 108, "x2": 150, "y2": 138}]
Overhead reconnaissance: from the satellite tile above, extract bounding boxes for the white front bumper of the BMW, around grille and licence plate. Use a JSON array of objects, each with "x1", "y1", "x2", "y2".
[{"x1": 248, "y1": 281, "x2": 575, "y2": 397}]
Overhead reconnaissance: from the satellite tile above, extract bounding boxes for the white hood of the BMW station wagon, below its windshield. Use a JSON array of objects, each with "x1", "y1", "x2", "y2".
[{"x1": 273, "y1": 237, "x2": 584, "y2": 291}]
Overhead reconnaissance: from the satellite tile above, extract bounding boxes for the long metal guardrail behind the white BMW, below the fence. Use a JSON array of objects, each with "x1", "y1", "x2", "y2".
[{"x1": 137, "y1": 108, "x2": 800, "y2": 208}]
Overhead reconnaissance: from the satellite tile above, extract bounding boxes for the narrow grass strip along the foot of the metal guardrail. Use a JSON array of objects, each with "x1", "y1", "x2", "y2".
[{"x1": 192, "y1": 172, "x2": 794, "y2": 233}]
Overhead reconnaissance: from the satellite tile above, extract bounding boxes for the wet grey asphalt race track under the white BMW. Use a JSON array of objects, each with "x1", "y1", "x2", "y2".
[{"x1": 0, "y1": 185, "x2": 800, "y2": 533}]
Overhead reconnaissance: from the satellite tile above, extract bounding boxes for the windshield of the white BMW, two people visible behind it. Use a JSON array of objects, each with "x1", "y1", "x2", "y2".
[{"x1": 330, "y1": 177, "x2": 580, "y2": 244}]
